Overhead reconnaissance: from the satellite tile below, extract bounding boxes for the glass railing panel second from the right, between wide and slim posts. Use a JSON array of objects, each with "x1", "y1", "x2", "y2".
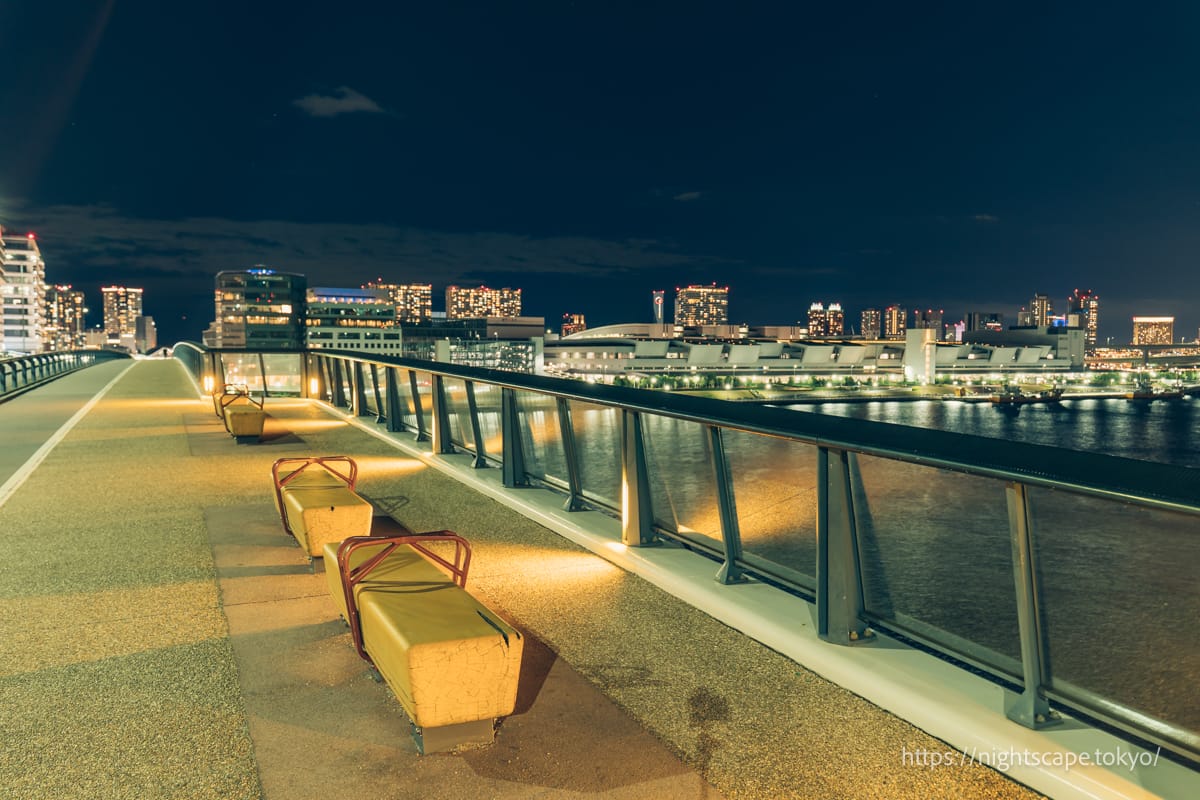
[{"x1": 849, "y1": 456, "x2": 1021, "y2": 676}]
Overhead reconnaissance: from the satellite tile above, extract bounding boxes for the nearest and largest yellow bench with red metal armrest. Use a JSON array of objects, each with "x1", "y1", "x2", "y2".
[{"x1": 325, "y1": 531, "x2": 524, "y2": 754}]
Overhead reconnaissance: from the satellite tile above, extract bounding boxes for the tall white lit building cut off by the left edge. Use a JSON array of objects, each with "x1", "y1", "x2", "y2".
[{"x1": 0, "y1": 230, "x2": 46, "y2": 354}]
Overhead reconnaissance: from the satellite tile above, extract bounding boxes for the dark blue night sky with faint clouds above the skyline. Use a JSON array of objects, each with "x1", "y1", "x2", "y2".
[{"x1": 0, "y1": 0, "x2": 1200, "y2": 344}]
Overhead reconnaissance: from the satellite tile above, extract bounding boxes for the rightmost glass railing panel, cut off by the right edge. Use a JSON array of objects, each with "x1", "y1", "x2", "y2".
[{"x1": 1030, "y1": 488, "x2": 1200, "y2": 732}]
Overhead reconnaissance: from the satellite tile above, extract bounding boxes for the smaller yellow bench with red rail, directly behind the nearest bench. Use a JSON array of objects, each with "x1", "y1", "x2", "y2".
[{"x1": 271, "y1": 456, "x2": 374, "y2": 560}]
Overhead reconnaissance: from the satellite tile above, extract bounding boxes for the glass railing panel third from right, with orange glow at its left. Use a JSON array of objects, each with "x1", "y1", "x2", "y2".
[{"x1": 724, "y1": 431, "x2": 817, "y2": 590}]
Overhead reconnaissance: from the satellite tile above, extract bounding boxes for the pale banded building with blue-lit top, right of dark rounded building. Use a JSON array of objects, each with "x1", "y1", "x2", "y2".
[{"x1": 304, "y1": 287, "x2": 401, "y2": 355}]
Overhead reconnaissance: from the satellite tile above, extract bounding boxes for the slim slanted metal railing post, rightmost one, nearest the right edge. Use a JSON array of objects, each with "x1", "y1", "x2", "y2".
[{"x1": 1004, "y1": 482, "x2": 1060, "y2": 728}]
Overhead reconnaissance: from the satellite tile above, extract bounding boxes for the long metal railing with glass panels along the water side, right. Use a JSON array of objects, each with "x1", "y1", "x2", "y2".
[{"x1": 175, "y1": 345, "x2": 1200, "y2": 763}]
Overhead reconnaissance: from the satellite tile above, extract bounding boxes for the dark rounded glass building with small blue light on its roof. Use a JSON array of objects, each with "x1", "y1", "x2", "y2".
[{"x1": 204, "y1": 266, "x2": 307, "y2": 350}]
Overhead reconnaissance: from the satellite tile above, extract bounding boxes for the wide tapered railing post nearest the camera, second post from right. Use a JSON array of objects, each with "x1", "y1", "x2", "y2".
[{"x1": 816, "y1": 447, "x2": 874, "y2": 644}]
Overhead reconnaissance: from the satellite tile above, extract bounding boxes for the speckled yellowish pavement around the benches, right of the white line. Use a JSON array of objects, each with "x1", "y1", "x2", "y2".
[{"x1": 0, "y1": 361, "x2": 1037, "y2": 800}]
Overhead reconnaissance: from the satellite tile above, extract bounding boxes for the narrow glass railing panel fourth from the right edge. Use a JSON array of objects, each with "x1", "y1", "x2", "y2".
[{"x1": 642, "y1": 414, "x2": 725, "y2": 552}]
